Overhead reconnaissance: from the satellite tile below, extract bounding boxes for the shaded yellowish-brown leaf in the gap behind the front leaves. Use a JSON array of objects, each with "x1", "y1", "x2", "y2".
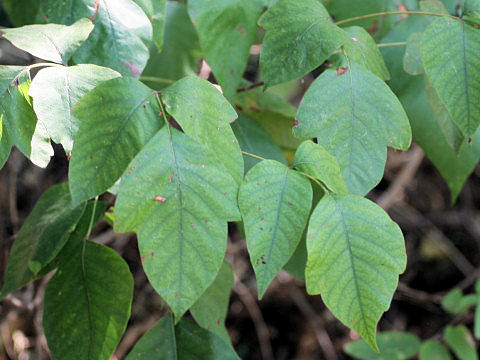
[{"x1": 235, "y1": 89, "x2": 302, "y2": 150}]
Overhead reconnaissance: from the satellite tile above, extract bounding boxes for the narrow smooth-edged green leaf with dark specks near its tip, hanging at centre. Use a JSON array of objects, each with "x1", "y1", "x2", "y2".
[{"x1": 238, "y1": 160, "x2": 312, "y2": 299}]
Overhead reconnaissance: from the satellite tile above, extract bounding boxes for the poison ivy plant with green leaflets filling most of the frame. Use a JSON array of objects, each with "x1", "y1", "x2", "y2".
[{"x1": 0, "y1": 0, "x2": 480, "y2": 360}]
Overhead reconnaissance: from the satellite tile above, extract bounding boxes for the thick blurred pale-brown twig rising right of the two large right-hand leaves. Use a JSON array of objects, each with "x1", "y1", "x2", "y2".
[{"x1": 377, "y1": 145, "x2": 424, "y2": 210}]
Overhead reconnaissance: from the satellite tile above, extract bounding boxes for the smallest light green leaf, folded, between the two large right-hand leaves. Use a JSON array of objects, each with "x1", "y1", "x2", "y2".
[{"x1": 293, "y1": 140, "x2": 348, "y2": 194}]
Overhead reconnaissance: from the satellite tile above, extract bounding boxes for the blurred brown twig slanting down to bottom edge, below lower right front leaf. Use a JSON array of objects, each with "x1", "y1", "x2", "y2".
[{"x1": 289, "y1": 285, "x2": 338, "y2": 360}]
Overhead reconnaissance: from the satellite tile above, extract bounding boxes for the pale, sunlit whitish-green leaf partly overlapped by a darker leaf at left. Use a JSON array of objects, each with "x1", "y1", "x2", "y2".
[{"x1": 29, "y1": 64, "x2": 120, "y2": 154}]
